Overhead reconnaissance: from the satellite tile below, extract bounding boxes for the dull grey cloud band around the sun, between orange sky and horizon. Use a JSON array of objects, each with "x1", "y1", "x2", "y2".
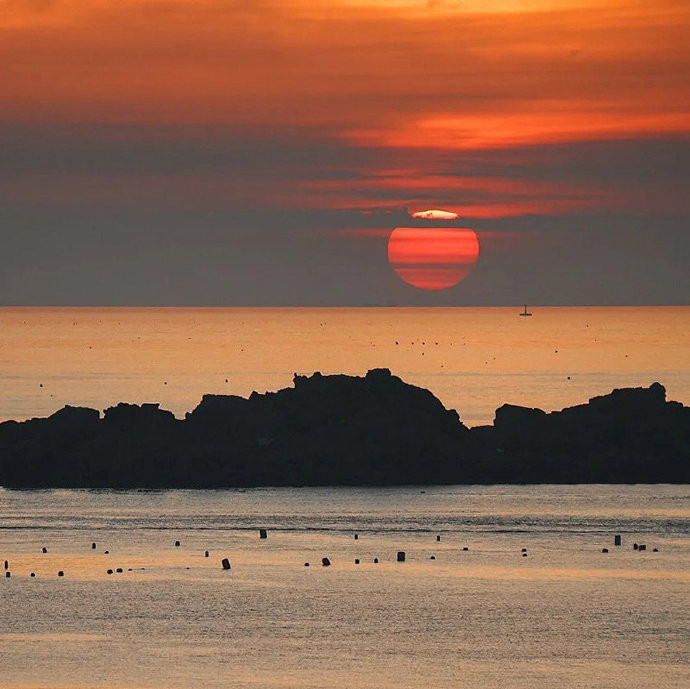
[{"x1": 0, "y1": 125, "x2": 690, "y2": 306}]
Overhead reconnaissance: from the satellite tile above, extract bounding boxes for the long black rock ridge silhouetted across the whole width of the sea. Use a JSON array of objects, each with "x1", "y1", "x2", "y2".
[{"x1": 0, "y1": 369, "x2": 690, "y2": 486}]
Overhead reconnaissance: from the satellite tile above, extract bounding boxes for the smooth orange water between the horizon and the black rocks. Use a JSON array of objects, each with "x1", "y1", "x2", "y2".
[{"x1": 0, "y1": 307, "x2": 690, "y2": 426}]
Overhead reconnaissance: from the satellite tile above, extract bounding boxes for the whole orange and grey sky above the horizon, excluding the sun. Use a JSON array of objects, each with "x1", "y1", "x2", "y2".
[{"x1": 0, "y1": 0, "x2": 690, "y2": 306}]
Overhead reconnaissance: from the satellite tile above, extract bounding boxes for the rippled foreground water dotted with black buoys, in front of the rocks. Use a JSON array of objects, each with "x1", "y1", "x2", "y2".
[{"x1": 0, "y1": 486, "x2": 690, "y2": 689}]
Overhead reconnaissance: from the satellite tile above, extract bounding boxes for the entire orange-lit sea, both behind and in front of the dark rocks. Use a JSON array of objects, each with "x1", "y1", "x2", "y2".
[{"x1": 0, "y1": 307, "x2": 690, "y2": 689}]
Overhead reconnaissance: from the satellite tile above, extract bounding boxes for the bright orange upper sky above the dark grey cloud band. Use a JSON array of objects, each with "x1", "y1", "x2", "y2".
[{"x1": 0, "y1": 0, "x2": 690, "y2": 127}]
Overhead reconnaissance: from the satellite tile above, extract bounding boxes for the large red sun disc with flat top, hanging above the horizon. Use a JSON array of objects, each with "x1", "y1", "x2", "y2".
[{"x1": 388, "y1": 227, "x2": 479, "y2": 290}]
